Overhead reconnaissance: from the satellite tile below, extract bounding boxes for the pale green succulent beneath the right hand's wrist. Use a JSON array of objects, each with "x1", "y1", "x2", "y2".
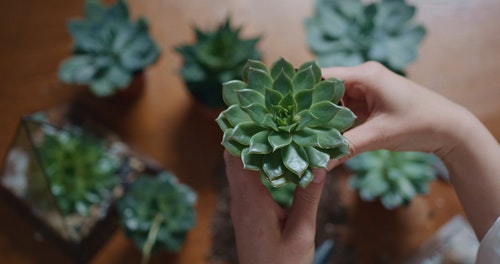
[{"x1": 345, "y1": 150, "x2": 438, "y2": 209}]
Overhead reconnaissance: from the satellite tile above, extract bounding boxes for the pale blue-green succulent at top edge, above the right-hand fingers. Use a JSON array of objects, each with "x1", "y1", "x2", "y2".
[{"x1": 305, "y1": 0, "x2": 426, "y2": 73}]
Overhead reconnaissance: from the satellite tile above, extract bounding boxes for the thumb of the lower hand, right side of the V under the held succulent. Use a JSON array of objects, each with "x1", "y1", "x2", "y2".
[{"x1": 284, "y1": 169, "x2": 326, "y2": 239}]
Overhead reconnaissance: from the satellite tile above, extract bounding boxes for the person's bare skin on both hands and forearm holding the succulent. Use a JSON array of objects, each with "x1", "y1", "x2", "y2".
[{"x1": 224, "y1": 62, "x2": 500, "y2": 264}]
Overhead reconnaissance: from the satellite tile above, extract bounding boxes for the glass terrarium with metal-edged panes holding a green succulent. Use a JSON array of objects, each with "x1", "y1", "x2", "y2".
[{"x1": 0, "y1": 105, "x2": 144, "y2": 262}]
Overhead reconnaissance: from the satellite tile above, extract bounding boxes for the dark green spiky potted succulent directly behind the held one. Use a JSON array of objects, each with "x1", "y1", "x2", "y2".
[{"x1": 176, "y1": 18, "x2": 261, "y2": 108}]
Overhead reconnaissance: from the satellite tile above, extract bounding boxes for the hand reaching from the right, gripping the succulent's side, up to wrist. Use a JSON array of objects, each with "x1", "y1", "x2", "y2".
[{"x1": 323, "y1": 62, "x2": 471, "y2": 169}]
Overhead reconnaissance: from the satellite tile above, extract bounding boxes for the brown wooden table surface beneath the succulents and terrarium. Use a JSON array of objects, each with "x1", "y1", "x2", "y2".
[{"x1": 0, "y1": 0, "x2": 500, "y2": 264}]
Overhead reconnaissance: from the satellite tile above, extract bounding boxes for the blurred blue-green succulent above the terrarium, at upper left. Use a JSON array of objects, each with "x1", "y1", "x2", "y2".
[{"x1": 59, "y1": 0, "x2": 160, "y2": 97}]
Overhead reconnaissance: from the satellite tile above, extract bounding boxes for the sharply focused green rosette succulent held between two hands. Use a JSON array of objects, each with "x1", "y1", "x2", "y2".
[{"x1": 217, "y1": 58, "x2": 355, "y2": 187}]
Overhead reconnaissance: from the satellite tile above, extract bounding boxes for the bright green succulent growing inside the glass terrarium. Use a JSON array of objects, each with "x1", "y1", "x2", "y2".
[{"x1": 36, "y1": 125, "x2": 120, "y2": 216}]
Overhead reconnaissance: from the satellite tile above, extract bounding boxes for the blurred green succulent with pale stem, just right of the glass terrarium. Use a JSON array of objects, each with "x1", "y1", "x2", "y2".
[{"x1": 117, "y1": 171, "x2": 196, "y2": 263}]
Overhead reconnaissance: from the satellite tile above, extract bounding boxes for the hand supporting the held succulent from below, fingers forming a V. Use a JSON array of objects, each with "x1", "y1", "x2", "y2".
[{"x1": 224, "y1": 151, "x2": 326, "y2": 264}]
